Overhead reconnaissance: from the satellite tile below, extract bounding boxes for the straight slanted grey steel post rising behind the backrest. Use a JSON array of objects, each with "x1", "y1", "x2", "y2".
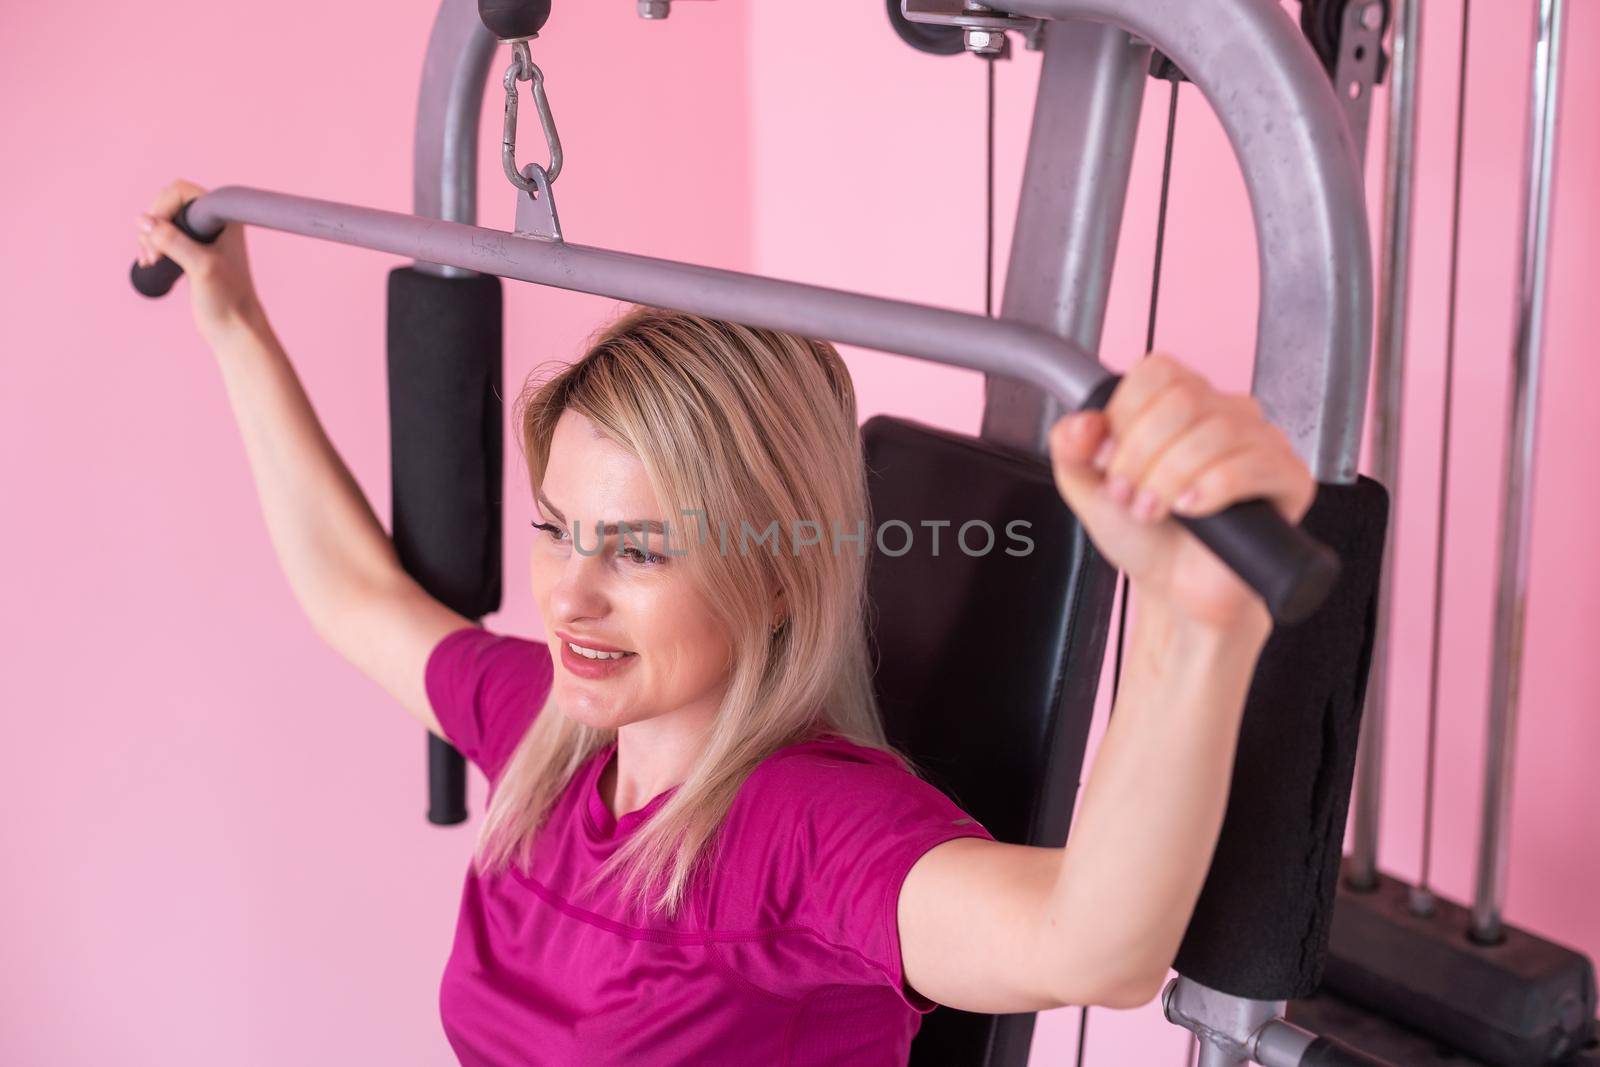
[{"x1": 981, "y1": 21, "x2": 1150, "y2": 454}]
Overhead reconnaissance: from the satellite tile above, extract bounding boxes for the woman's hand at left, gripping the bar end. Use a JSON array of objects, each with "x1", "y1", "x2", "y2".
[{"x1": 139, "y1": 179, "x2": 266, "y2": 347}]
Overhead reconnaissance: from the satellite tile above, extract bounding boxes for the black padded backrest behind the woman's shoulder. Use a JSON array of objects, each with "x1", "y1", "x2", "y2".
[{"x1": 862, "y1": 416, "x2": 1117, "y2": 1067}]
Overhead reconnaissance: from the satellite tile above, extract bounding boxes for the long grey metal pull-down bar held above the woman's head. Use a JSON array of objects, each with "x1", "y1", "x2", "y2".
[{"x1": 189, "y1": 186, "x2": 1109, "y2": 410}]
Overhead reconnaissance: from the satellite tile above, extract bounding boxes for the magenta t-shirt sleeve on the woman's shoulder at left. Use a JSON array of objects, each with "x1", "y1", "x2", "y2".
[{"x1": 424, "y1": 625, "x2": 555, "y2": 782}]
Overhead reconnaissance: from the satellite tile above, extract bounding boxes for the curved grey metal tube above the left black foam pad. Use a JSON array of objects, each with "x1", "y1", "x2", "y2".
[{"x1": 411, "y1": 0, "x2": 498, "y2": 277}]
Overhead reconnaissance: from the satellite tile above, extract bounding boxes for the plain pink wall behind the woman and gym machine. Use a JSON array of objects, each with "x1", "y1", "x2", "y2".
[{"x1": 0, "y1": 0, "x2": 1600, "y2": 1067}]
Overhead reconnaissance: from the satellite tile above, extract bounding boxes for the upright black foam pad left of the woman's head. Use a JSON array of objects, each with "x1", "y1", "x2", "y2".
[{"x1": 389, "y1": 267, "x2": 504, "y2": 619}]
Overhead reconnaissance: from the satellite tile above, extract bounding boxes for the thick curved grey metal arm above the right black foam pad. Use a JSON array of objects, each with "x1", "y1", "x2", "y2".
[{"x1": 986, "y1": 0, "x2": 1373, "y2": 483}]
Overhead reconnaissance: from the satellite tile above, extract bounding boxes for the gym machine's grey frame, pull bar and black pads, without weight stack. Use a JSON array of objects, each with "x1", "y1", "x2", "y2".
[{"x1": 133, "y1": 0, "x2": 1452, "y2": 1067}]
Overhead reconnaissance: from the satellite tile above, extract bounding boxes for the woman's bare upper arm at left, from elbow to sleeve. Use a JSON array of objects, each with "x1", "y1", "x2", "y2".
[{"x1": 318, "y1": 571, "x2": 475, "y2": 741}]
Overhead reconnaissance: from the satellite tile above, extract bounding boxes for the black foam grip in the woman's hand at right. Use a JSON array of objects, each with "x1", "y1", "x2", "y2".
[{"x1": 1083, "y1": 374, "x2": 1339, "y2": 625}]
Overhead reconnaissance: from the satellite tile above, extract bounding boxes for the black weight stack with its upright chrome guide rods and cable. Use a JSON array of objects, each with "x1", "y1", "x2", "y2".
[{"x1": 1291, "y1": 0, "x2": 1600, "y2": 1067}]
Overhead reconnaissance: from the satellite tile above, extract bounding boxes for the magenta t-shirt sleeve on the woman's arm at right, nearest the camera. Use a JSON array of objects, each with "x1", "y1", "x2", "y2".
[{"x1": 771, "y1": 757, "x2": 994, "y2": 1014}]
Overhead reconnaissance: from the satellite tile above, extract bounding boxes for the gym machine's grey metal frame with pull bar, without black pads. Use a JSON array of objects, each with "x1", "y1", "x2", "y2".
[{"x1": 134, "y1": 0, "x2": 1376, "y2": 1067}]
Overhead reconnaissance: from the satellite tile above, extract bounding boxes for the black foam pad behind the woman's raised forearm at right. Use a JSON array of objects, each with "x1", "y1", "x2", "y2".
[{"x1": 1174, "y1": 477, "x2": 1389, "y2": 1000}]
